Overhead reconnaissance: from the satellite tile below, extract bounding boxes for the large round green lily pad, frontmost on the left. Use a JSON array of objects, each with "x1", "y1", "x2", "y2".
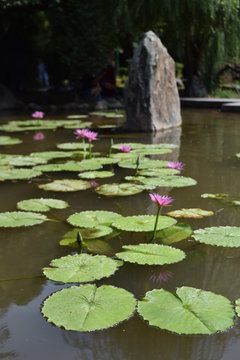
[{"x1": 42, "y1": 284, "x2": 136, "y2": 331}]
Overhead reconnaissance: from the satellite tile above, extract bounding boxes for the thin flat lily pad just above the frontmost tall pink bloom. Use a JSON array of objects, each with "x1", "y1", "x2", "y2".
[{"x1": 125, "y1": 175, "x2": 197, "y2": 187}]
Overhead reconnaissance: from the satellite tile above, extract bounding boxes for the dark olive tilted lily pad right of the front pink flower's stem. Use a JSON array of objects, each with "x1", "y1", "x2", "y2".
[{"x1": 155, "y1": 223, "x2": 192, "y2": 245}]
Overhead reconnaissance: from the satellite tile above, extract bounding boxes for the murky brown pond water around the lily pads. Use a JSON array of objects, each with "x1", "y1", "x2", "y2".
[{"x1": 0, "y1": 110, "x2": 240, "y2": 360}]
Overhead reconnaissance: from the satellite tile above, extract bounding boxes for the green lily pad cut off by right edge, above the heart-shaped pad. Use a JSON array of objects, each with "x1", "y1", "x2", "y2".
[{"x1": 193, "y1": 226, "x2": 240, "y2": 247}]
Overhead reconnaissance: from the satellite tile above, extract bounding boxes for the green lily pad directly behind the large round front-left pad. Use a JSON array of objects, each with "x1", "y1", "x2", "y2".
[{"x1": 43, "y1": 254, "x2": 122, "y2": 283}]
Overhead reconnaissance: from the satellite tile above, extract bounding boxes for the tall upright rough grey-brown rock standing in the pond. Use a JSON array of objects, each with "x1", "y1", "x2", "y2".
[{"x1": 125, "y1": 31, "x2": 182, "y2": 131}]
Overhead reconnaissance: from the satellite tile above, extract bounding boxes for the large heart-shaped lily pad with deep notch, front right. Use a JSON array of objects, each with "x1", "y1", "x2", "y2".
[{"x1": 138, "y1": 286, "x2": 235, "y2": 334}]
